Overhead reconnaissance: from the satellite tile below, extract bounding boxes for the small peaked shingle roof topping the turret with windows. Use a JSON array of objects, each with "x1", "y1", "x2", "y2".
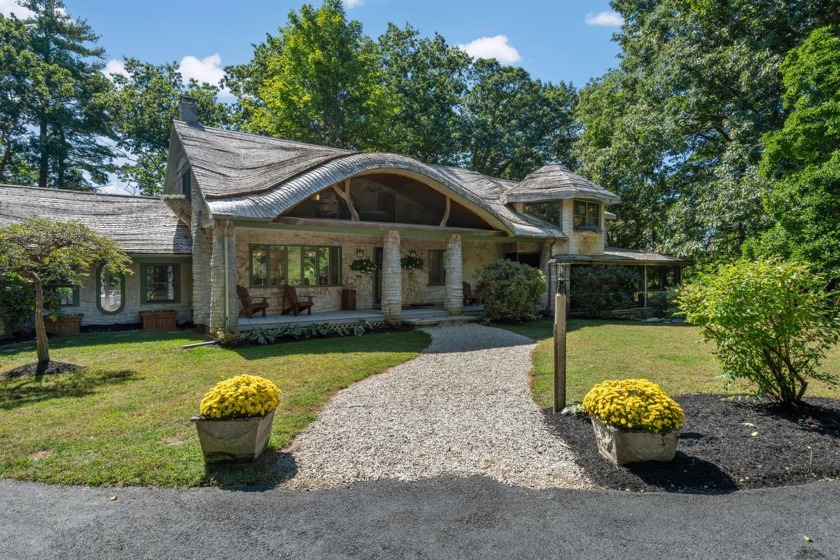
[{"x1": 505, "y1": 163, "x2": 619, "y2": 204}]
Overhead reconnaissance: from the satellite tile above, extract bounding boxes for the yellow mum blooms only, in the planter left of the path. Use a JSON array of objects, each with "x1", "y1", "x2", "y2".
[{"x1": 200, "y1": 375, "x2": 280, "y2": 420}]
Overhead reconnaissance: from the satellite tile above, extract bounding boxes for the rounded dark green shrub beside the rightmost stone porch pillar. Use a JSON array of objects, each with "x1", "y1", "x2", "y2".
[{"x1": 477, "y1": 259, "x2": 545, "y2": 321}]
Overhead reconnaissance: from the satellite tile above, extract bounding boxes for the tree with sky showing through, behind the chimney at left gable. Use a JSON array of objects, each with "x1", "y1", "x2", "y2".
[{"x1": 111, "y1": 58, "x2": 232, "y2": 196}]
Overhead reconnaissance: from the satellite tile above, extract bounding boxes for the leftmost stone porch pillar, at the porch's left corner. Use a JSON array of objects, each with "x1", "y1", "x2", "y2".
[{"x1": 210, "y1": 220, "x2": 239, "y2": 332}]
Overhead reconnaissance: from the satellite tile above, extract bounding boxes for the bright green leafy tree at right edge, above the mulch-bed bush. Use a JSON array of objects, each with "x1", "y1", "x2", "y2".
[{"x1": 757, "y1": 27, "x2": 840, "y2": 279}]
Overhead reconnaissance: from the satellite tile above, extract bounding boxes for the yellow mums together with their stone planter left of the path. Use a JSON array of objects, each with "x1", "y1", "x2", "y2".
[{"x1": 192, "y1": 375, "x2": 280, "y2": 463}]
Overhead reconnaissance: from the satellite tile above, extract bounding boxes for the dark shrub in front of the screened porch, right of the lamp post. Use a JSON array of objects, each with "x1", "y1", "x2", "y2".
[{"x1": 569, "y1": 265, "x2": 639, "y2": 317}]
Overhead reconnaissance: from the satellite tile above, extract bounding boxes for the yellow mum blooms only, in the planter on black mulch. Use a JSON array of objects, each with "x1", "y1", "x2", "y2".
[{"x1": 583, "y1": 379, "x2": 685, "y2": 434}]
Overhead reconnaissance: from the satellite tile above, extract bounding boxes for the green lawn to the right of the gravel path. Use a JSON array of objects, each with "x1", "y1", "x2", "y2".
[{"x1": 504, "y1": 320, "x2": 840, "y2": 406}]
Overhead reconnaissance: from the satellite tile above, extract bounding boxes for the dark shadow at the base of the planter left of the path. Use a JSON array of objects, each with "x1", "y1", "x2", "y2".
[{"x1": 201, "y1": 447, "x2": 298, "y2": 492}]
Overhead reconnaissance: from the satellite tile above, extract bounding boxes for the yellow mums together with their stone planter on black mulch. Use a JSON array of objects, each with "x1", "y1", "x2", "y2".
[{"x1": 583, "y1": 379, "x2": 685, "y2": 466}]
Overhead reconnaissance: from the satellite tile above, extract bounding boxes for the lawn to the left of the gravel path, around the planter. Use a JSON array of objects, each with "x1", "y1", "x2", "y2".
[{"x1": 0, "y1": 331, "x2": 428, "y2": 487}]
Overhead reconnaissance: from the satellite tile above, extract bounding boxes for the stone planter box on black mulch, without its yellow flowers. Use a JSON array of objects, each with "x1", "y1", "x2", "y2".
[{"x1": 590, "y1": 416, "x2": 680, "y2": 466}]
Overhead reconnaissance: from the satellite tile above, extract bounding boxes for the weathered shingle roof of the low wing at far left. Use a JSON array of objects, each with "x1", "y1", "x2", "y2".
[{"x1": 0, "y1": 185, "x2": 192, "y2": 255}]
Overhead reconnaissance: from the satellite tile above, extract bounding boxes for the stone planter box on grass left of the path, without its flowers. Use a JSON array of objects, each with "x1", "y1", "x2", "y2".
[{"x1": 191, "y1": 410, "x2": 274, "y2": 463}]
